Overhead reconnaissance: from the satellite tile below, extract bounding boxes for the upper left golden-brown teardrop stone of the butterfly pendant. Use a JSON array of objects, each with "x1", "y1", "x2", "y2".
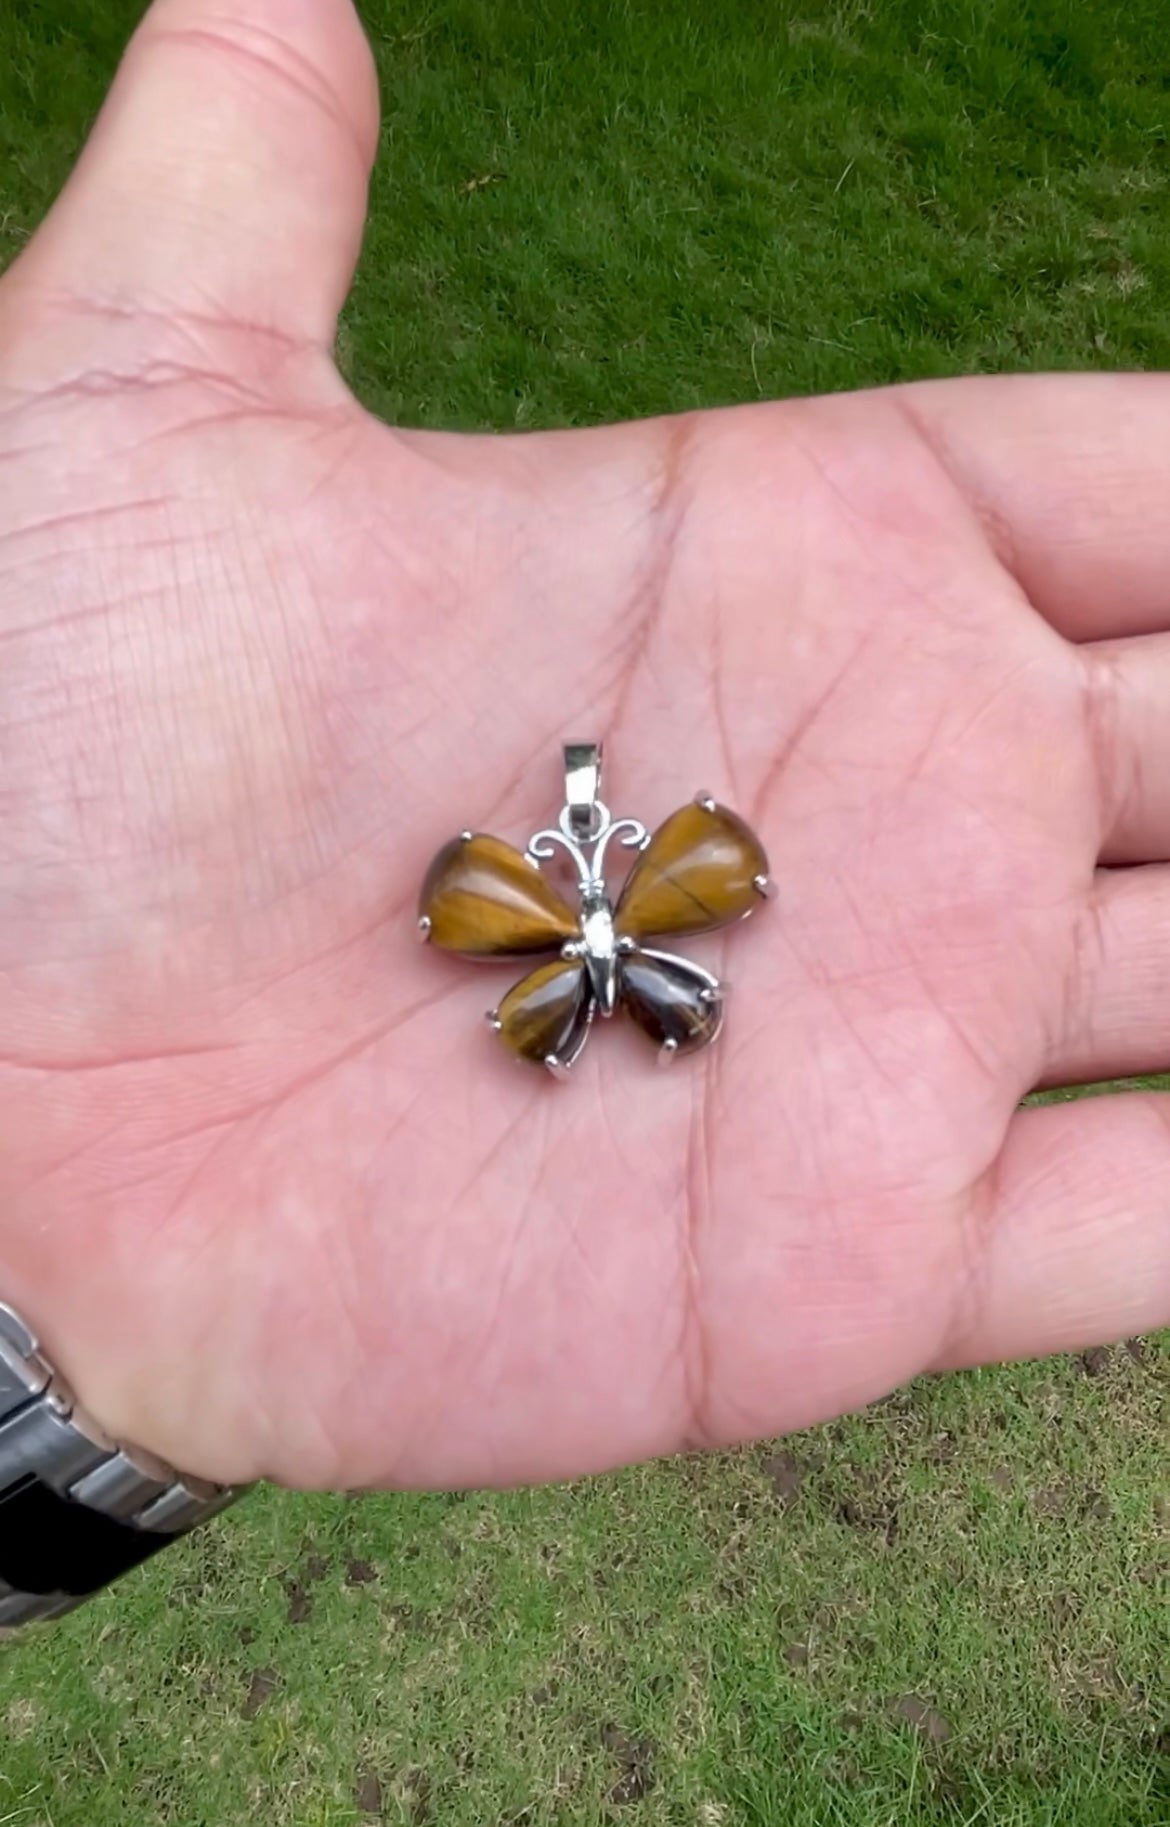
[{"x1": 419, "y1": 835, "x2": 578, "y2": 957}]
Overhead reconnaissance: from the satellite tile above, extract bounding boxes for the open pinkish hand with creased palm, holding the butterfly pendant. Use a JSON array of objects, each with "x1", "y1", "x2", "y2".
[{"x1": 0, "y1": 0, "x2": 1170, "y2": 1485}]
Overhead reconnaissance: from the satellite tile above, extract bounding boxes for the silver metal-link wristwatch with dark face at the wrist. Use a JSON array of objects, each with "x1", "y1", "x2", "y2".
[{"x1": 0, "y1": 1303, "x2": 243, "y2": 1626}]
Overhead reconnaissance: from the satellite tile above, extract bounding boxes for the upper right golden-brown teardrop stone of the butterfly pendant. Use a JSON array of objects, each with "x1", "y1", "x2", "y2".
[{"x1": 614, "y1": 804, "x2": 768, "y2": 939}]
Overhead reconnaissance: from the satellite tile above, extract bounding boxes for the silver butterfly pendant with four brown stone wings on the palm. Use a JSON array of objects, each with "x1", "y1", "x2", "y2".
[{"x1": 419, "y1": 744, "x2": 775, "y2": 1078}]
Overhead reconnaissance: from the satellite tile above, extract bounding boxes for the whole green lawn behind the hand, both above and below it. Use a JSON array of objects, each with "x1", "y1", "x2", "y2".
[{"x1": 0, "y1": 0, "x2": 1170, "y2": 1827}]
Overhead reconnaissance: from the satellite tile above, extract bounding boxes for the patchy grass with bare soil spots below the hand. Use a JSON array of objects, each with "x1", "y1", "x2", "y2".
[{"x1": 0, "y1": 1343, "x2": 1170, "y2": 1827}]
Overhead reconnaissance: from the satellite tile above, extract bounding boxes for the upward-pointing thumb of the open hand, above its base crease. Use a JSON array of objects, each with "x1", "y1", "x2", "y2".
[{"x1": 5, "y1": 0, "x2": 378, "y2": 343}]
